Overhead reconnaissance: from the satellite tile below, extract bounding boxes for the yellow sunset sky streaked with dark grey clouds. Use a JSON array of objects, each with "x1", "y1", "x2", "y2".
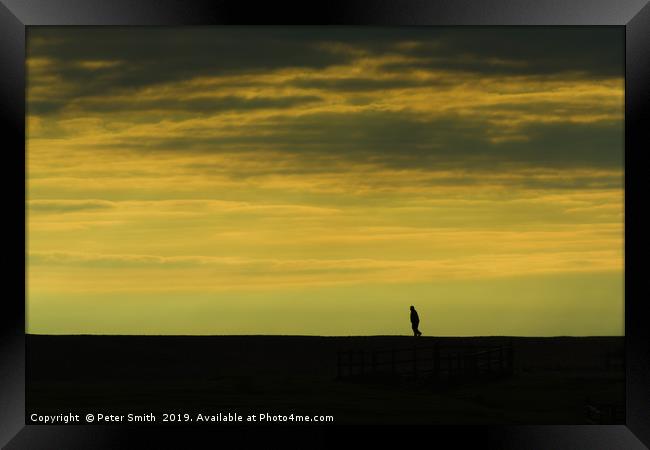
[{"x1": 26, "y1": 27, "x2": 624, "y2": 336}]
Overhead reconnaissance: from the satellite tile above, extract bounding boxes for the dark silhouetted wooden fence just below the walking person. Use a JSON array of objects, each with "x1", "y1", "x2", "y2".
[{"x1": 337, "y1": 343, "x2": 513, "y2": 380}]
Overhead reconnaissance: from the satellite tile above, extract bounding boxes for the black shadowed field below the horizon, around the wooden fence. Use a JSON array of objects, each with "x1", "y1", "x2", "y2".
[{"x1": 26, "y1": 335, "x2": 625, "y2": 424}]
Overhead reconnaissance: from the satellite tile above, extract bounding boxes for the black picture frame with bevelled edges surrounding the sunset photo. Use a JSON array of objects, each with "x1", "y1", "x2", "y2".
[{"x1": 0, "y1": 0, "x2": 650, "y2": 450}]
